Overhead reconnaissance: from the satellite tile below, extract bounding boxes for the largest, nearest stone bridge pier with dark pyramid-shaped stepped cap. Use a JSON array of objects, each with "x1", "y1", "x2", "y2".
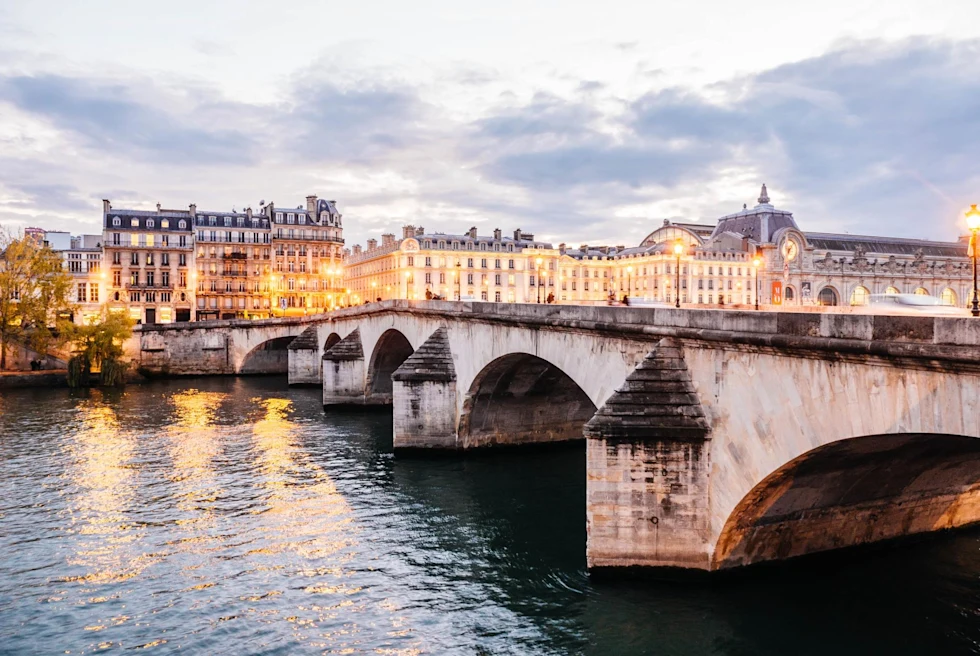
[{"x1": 585, "y1": 339, "x2": 711, "y2": 569}]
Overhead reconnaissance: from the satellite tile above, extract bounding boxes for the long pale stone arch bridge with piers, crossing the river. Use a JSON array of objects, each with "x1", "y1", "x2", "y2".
[{"x1": 129, "y1": 301, "x2": 980, "y2": 570}]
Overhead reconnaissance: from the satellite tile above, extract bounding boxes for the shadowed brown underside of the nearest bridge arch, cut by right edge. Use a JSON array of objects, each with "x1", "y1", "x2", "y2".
[{"x1": 711, "y1": 433, "x2": 980, "y2": 569}]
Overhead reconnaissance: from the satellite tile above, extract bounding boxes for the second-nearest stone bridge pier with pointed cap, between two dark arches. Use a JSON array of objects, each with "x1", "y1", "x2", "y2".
[{"x1": 391, "y1": 328, "x2": 457, "y2": 451}]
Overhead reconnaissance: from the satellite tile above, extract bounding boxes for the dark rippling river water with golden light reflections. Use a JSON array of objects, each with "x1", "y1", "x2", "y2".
[{"x1": 0, "y1": 378, "x2": 980, "y2": 656}]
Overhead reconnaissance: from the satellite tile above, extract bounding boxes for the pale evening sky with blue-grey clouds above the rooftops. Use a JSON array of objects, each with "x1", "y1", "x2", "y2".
[{"x1": 0, "y1": 0, "x2": 980, "y2": 245}]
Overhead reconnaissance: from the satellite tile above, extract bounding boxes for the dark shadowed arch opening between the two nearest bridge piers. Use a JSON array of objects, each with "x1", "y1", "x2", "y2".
[{"x1": 459, "y1": 353, "x2": 596, "y2": 447}]
